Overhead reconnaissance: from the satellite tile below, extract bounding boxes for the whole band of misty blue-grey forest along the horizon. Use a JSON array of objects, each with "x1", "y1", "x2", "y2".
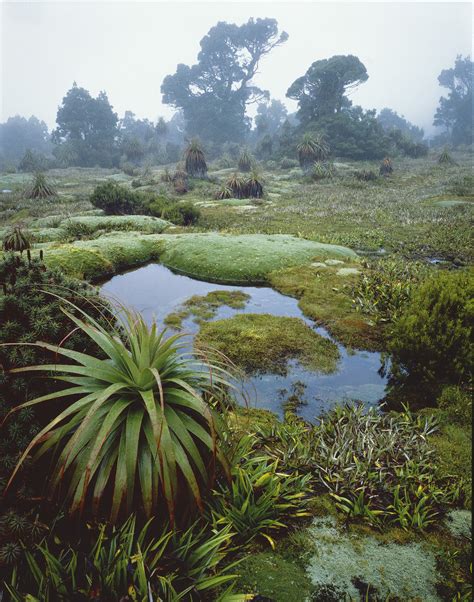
[{"x1": 0, "y1": 19, "x2": 473, "y2": 172}]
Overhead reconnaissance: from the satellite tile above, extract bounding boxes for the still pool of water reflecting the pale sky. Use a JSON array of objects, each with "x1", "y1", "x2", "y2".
[{"x1": 101, "y1": 264, "x2": 386, "y2": 421}]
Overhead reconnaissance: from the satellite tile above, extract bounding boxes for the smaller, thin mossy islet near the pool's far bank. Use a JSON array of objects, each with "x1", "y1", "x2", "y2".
[{"x1": 165, "y1": 291, "x2": 250, "y2": 330}]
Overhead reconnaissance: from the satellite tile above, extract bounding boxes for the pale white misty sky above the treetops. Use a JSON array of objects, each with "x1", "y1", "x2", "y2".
[{"x1": 0, "y1": 0, "x2": 472, "y2": 132}]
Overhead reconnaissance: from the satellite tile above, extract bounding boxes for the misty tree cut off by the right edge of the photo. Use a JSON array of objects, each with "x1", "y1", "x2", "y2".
[{"x1": 433, "y1": 55, "x2": 473, "y2": 146}]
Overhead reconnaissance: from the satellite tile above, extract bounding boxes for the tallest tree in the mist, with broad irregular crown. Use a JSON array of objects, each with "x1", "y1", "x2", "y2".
[{"x1": 161, "y1": 19, "x2": 288, "y2": 143}]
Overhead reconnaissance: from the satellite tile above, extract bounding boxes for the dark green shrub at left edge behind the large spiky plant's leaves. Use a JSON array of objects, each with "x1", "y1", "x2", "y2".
[{"x1": 0, "y1": 253, "x2": 110, "y2": 568}]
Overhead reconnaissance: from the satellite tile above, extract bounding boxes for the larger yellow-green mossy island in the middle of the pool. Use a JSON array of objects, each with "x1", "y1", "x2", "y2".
[{"x1": 196, "y1": 314, "x2": 339, "y2": 374}]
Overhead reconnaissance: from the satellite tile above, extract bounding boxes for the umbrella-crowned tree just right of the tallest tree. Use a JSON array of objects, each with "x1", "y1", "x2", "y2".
[{"x1": 286, "y1": 54, "x2": 369, "y2": 125}]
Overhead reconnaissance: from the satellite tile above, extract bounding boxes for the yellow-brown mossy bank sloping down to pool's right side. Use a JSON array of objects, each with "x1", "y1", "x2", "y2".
[{"x1": 269, "y1": 261, "x2": 383, "y2": 350}]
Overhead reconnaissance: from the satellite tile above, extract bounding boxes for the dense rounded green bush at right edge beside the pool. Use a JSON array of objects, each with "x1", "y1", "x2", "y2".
[{"x1": 388, "y1": 272, "x2": 474, "y2": 406}]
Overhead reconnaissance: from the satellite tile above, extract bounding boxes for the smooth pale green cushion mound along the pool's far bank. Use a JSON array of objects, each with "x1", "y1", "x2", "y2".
[{"x1": 161, "y1": 233, "x2": 357, "y2": 283}]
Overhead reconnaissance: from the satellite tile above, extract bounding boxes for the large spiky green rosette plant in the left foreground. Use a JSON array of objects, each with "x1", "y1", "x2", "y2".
[{"x1": 1, "y1": 295, "x2": 232, "y2": 523}]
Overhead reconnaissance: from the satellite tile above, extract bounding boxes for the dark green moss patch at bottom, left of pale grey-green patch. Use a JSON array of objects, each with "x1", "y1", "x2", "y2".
[{"x1": 235, "y1": 552, "x2": 312, "y2": 602}]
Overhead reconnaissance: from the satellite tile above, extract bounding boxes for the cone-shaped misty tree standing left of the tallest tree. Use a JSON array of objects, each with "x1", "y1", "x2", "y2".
[{"x1": 53, "y1": 82, "x2": 118, "y2": 167}]
